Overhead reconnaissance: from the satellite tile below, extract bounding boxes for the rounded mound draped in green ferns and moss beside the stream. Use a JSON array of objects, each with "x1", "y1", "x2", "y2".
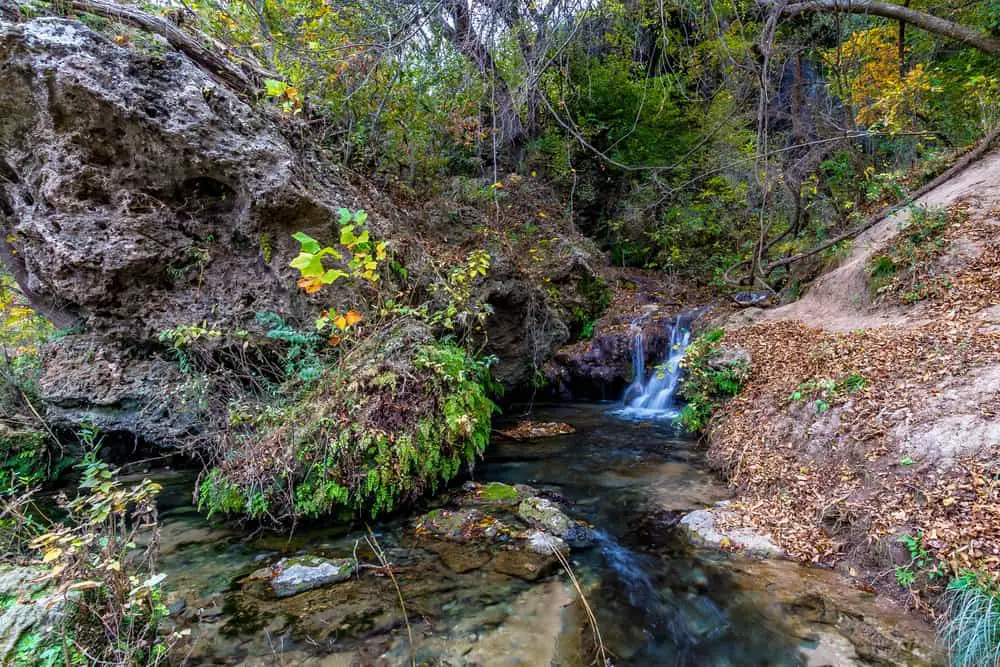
[{"x1": 198, "y1": 322, "x2": 494, "y2": 522}]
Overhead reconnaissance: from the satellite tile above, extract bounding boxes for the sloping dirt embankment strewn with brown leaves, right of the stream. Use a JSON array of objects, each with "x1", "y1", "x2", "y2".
[{"x1": 709, "y1": 152, "x2": 1000, "y2": 609}]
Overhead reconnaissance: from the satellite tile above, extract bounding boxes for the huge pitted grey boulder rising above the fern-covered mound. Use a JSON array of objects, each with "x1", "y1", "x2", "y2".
[{"x1": 0, "y1": 18, "x2": 593, "y2": 444}]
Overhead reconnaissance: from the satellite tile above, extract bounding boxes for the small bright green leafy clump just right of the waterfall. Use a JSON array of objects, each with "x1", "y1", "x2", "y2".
[{"x1": 677, "y1": 329, "x2": 750, "y2": 433}]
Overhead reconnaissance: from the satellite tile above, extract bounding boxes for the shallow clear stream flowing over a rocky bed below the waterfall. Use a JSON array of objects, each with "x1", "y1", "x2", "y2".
[{"x1": 150, "y1": 404, "x2": 936, "y2": 666}]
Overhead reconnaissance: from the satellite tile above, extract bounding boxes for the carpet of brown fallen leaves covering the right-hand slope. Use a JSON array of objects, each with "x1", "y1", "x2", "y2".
[{"x1": 709, "y1": 240, "x2": 1000, "y2": 576}]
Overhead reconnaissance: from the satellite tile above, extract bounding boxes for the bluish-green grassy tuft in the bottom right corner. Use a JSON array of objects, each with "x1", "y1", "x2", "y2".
[{"x1": 940, "y1": 571, "x2": 1000, "y2": 667}]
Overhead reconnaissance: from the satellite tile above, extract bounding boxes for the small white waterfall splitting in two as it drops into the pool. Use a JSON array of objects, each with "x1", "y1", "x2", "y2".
[{"x1": 621, "y1": 315, "x2": 691, "y2": 418}]
